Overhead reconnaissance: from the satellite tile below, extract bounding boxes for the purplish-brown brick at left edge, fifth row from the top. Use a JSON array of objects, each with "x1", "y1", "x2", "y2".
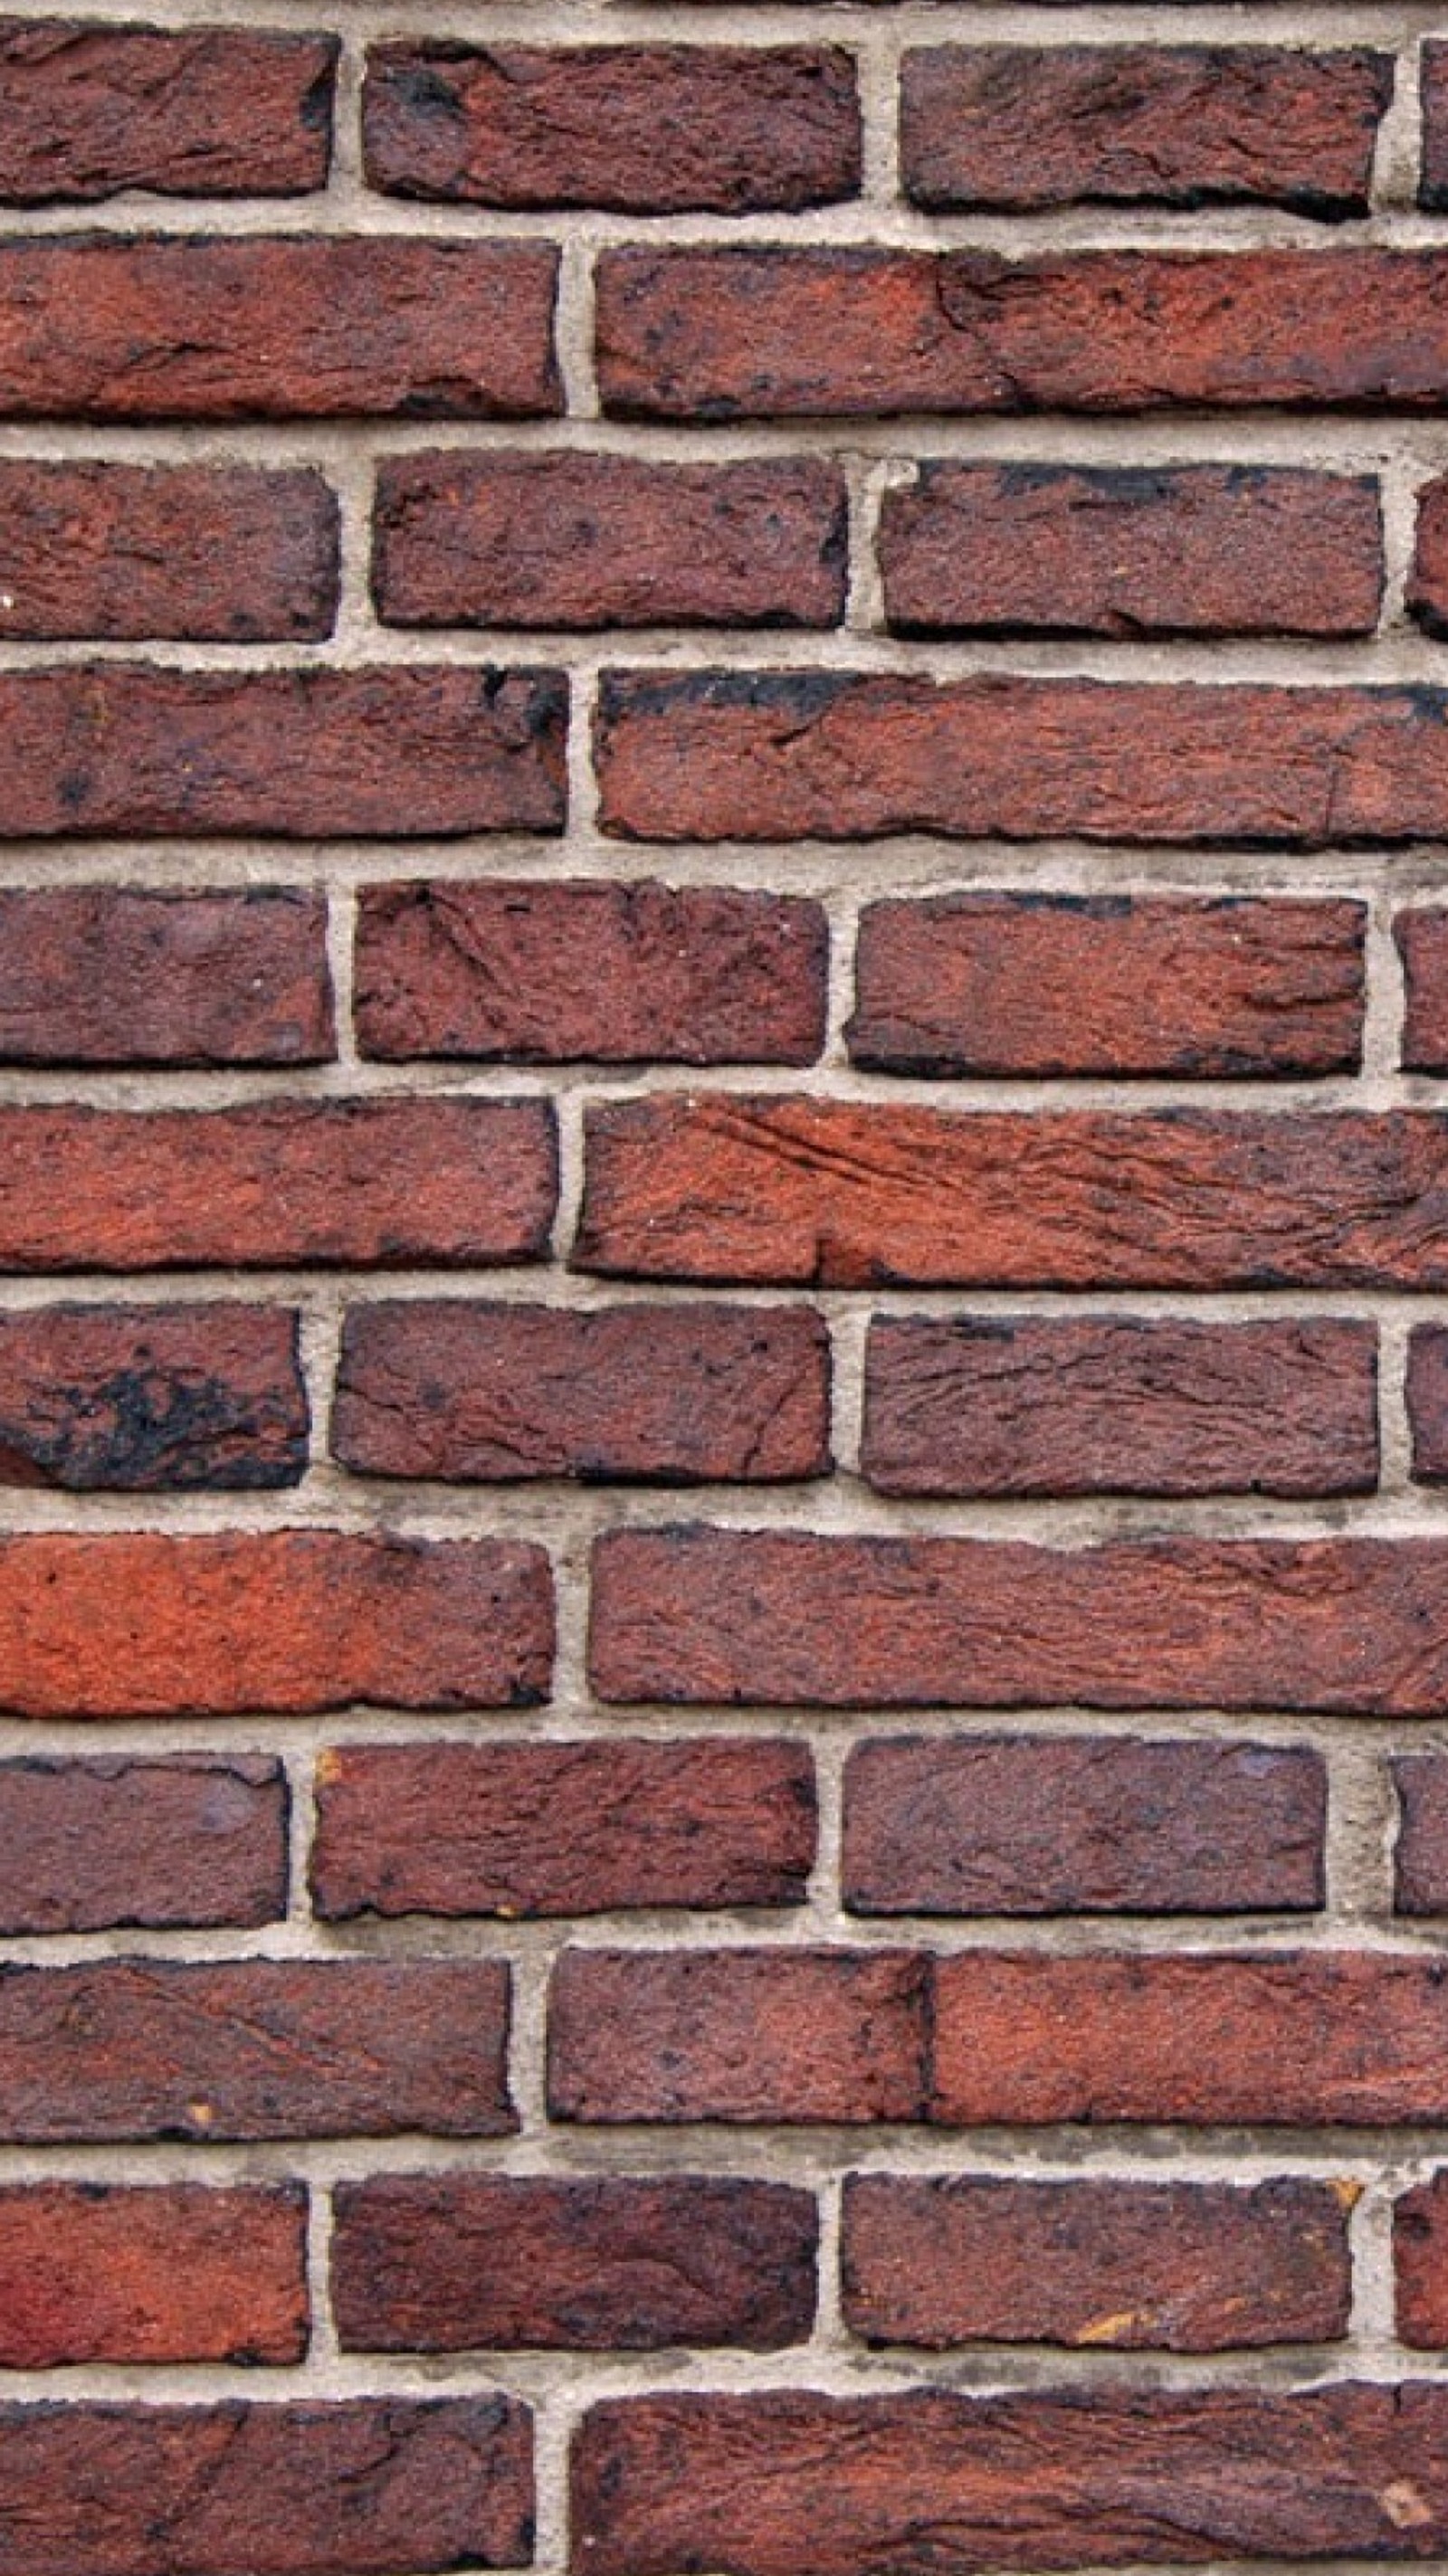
[{"x1": 0, "y1": 886, "x2": 338, "y2": 1064}]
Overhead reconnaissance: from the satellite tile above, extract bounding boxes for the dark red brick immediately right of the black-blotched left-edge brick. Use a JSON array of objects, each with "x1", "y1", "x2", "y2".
[{"x1": 327, "y1": 1298, "x2": 830, "y2": 1484}]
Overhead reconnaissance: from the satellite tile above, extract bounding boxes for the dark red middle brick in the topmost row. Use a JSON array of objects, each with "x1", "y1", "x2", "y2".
[{"x1": 363, "y1": 39, "x2": 861, "y2": 214}]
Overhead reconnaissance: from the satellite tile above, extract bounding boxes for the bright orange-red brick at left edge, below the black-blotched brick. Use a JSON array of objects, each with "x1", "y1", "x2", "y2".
[{"x1": 0, "y1": 1530, "x2": 551, "y2": 1718}]
